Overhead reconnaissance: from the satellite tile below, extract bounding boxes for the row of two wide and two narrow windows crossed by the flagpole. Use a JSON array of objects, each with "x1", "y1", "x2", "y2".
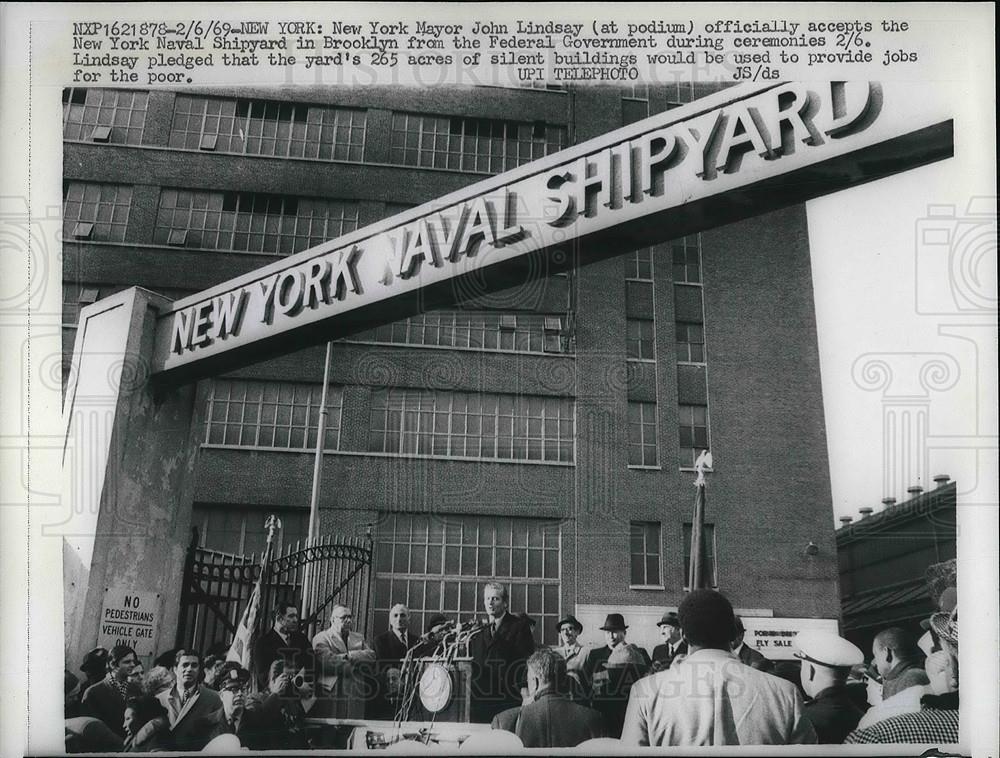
[{"x1": 204, "y1": 379, "x2": 708, "y2": 466}]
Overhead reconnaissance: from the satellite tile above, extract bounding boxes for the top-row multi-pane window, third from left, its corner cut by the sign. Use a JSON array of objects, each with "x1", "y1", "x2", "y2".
[{"x1": 389, "y1": 113, "x2": 566, "y2": 174}]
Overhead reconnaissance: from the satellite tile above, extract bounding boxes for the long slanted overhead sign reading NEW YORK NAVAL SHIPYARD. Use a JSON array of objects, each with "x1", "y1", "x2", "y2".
[{"x1": 153, "y1": 82, "x2": 953, "y2": 377}]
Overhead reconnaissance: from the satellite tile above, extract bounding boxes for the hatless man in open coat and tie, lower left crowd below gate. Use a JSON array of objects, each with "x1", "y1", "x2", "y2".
[{"x1": 156, "y1": 648, "x2": 222, "y2": 750}]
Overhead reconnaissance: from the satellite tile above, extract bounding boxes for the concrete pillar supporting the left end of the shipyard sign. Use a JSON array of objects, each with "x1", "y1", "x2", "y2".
[{"x1": 61, "y1": 288, "x2": 201, "y2": 670}]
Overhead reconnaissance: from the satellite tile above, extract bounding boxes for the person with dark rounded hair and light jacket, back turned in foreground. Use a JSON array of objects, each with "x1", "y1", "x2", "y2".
[{"x1": 622, "y1": 590, "x2": 816, "y2": 747}]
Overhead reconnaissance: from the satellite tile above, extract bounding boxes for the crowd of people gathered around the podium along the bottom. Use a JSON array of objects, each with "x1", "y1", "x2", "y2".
[{"x1": 66, "y1": 582, "x2": 958, "y2": 752}]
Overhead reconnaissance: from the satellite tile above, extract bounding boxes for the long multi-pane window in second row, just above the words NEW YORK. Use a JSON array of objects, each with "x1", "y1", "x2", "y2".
[{"x1": 153, "y1": 188, "x2": 358, "y2": 254}]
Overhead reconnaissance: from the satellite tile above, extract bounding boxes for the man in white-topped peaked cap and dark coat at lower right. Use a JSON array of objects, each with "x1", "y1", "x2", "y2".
[{"x1": 794, "y1": 631, "x2": 865, "y2": 745}]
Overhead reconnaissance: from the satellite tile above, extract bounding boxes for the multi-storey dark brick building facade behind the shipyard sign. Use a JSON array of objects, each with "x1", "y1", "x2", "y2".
[{"x1": 64, "y1": 85, "x2": 839, "y2": 642}]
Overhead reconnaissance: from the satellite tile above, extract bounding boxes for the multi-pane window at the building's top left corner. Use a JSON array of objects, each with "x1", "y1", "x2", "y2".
[{"x1": 63, "y1": 87, "x2": 149, "y2": 145}]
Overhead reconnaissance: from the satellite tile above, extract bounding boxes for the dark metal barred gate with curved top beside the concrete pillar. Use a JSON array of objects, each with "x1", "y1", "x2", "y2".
[{"x1": 175, "y1": 528, "x2": 373, "y2": 652}]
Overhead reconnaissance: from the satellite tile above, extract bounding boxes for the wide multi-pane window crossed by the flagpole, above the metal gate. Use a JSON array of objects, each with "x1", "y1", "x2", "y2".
[{"x1": 205, "y1": 379, "x2": 343, "y2": 450}]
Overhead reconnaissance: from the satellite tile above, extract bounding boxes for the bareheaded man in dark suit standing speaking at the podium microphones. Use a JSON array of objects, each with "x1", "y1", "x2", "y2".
[{"x1": 469, "y1": 582, "x2": 535, "y2": 724}]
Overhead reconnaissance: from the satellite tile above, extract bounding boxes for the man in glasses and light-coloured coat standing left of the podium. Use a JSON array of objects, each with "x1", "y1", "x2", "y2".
[{"x1": 310, "y1": 605, "x2": 375, "y2": 719}]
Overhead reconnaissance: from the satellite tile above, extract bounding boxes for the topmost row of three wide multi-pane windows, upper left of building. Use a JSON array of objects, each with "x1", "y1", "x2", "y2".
[{"x1": 63, "y1": 88, "x2": 568, "y2": 173}]
